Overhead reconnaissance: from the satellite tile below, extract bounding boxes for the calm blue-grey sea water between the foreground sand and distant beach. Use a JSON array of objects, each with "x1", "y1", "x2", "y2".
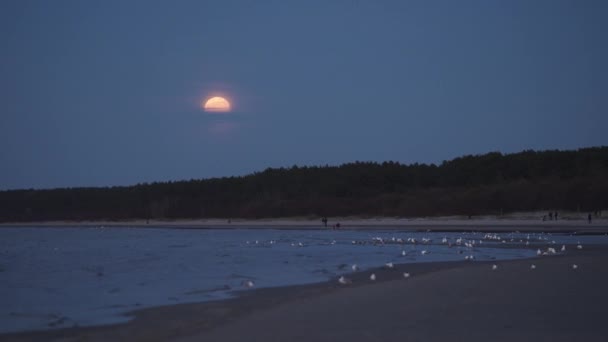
[{"x1": 0, "y1": 227, "x2": 608, "y2": 332}]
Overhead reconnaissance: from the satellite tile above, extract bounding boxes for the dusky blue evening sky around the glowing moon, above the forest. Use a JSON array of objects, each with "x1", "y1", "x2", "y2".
[{"x1": 0, "y1": 0, "x2": 608, "y2": 189}]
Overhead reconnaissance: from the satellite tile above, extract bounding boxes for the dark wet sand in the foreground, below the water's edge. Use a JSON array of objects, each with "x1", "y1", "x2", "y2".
[{"x1": 0, "y1": 246, "x2": 608, "y2": 342}]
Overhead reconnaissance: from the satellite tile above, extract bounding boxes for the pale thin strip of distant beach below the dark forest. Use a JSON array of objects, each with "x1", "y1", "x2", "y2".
[{"x1": 0, "y1": 213, "x2": 608, "y2": 233}]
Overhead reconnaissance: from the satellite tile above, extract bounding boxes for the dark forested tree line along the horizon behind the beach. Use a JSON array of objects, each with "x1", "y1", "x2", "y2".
[{"x1": 0, "y1": 147, "x2": 608, "y2": 222}]
